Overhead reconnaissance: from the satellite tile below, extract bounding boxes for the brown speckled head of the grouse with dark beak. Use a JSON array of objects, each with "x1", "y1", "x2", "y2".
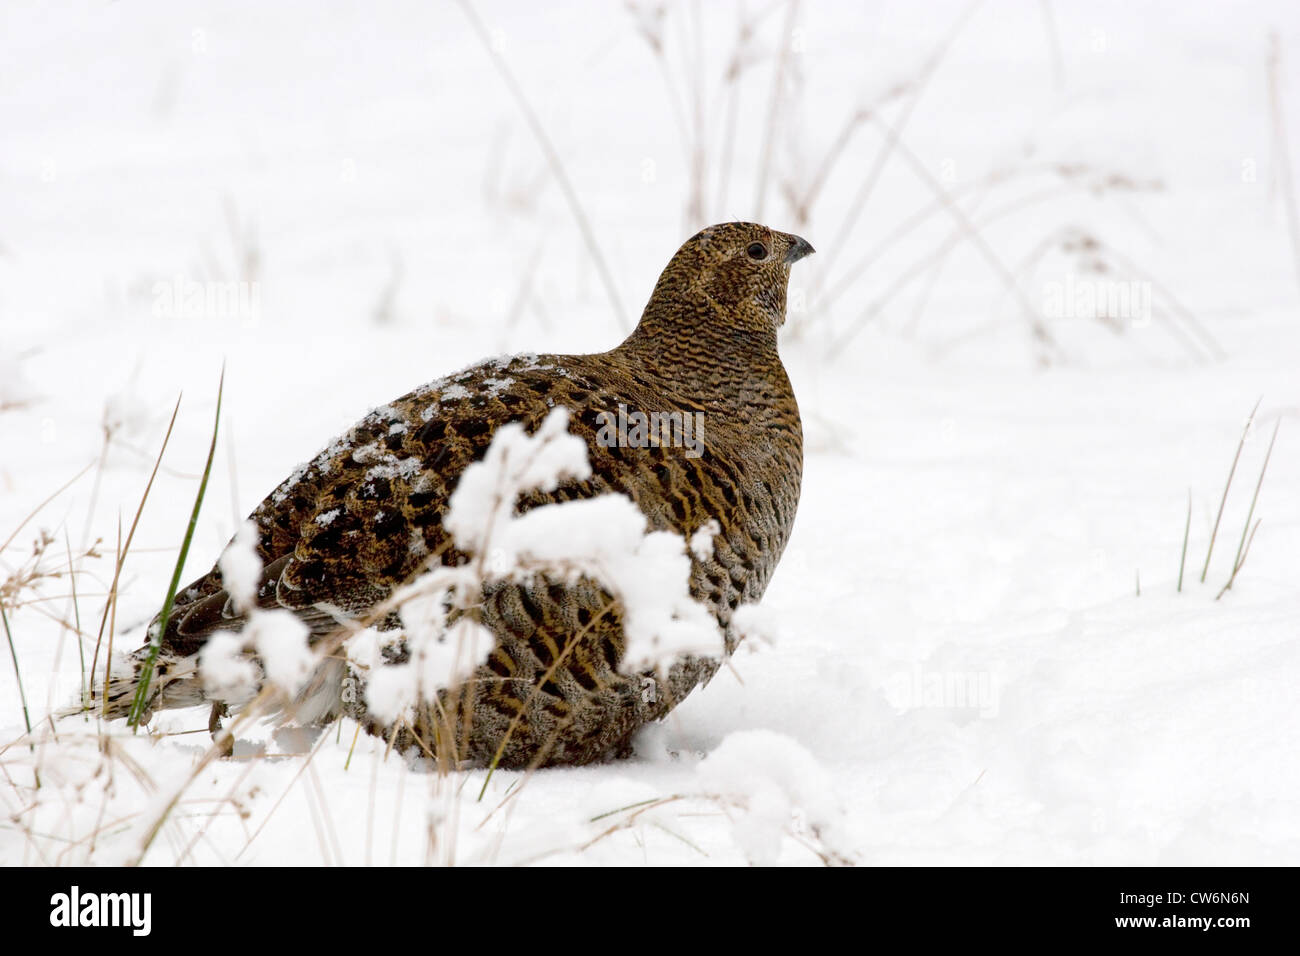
[{"x1": 646, "y1": 222, "x2": 814, "y2": 334}]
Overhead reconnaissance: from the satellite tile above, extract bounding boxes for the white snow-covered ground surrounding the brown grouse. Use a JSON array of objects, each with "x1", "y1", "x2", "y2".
[{"x1": 0, "y1": 0, "x2": 1300, "y2": 865}]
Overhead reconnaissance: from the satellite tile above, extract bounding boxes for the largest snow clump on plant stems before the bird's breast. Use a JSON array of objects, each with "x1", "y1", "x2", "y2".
[{"x1": 354, "y1": 407, "x2": 723, "y2": 723}]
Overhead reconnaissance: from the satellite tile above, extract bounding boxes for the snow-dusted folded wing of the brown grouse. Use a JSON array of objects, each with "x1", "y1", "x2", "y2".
[{"x1": 153, "y1": 355, "x2": 624, "y2": 654}]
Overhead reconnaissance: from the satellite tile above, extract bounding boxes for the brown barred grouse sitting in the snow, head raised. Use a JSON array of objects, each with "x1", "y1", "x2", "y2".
[{"x1": 104, "y1": 222, "x2": 814, "y2": 767}]
